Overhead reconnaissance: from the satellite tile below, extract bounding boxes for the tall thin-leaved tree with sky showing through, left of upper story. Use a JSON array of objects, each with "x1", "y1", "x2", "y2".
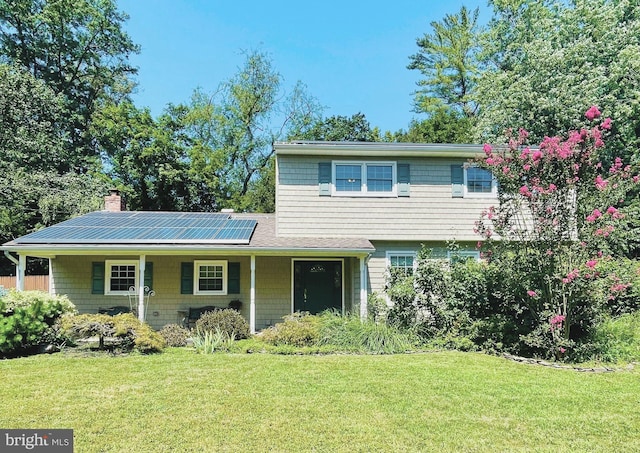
[{"x1": 186, "y1": 51, "x2": 320, "y2": 211}]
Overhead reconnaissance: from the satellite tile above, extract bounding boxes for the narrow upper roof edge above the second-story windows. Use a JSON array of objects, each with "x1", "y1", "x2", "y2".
[{"x1": 274, "y1": 140, "x2": 484, "y2": 158}]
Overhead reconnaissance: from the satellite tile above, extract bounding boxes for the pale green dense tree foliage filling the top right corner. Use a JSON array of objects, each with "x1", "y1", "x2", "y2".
[{"x1": 476, "y1": 0, "x2": 640, "y2": 158}]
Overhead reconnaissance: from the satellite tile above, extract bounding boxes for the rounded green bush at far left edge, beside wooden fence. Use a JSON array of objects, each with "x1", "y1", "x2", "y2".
[{"x1": 0, "y1": 290, "x2": 75, "y2": 356}]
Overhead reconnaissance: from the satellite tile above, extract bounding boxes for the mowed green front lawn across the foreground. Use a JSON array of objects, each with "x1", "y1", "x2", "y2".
[{"x1": 0, "y1": 349, "x2": 640, "y2": 452}]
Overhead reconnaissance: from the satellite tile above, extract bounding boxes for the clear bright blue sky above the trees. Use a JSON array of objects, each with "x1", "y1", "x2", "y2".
[{"x1": 118, "y1": 0, "x2": 490, "y2": 131}]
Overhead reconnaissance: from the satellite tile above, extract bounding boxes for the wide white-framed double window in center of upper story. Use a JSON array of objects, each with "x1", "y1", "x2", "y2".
[{"x1": 333, "y1": 162, "x2": 397, "y2": 196}]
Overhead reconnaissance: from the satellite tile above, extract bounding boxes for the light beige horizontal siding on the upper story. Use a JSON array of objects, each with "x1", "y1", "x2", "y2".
[{"x1": 276, "y1": 155, "x2": 497, "y2": 241}]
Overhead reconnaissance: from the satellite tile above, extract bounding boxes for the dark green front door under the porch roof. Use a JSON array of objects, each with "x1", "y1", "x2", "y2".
[{"x1": 293, "y1": 261, "x2": 342, "y2": 314}]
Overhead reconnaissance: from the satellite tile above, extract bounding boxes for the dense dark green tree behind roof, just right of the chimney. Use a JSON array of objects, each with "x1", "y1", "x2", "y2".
[{"x1": 93, "y1": 101, "x2": 194, "y2": 211}]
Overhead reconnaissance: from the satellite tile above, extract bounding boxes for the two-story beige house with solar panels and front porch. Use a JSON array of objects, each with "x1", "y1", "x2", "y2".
[{"x1": 0, "y1": 141, "x2": 497, "y2": 331}]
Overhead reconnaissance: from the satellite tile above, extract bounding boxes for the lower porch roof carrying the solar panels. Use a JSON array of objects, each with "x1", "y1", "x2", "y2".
[{"x1": 0, "y1": 211, "x2": 375, "y2": 256}]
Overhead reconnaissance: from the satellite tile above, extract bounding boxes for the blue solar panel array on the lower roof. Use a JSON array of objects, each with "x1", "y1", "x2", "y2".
[{"x1": 14, "y1": 211, "x2": 257, "y2": 244}]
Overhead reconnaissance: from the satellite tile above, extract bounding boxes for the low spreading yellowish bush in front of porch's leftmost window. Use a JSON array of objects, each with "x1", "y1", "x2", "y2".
[{"x1": 62, "y1": 313, "x2": 166, "y2": 353}]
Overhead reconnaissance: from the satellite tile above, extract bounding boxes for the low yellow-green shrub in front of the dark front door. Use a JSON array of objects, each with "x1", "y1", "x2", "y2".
[{"x1": 260, "y1": 313, "x2": 320, "y2": 347}]
